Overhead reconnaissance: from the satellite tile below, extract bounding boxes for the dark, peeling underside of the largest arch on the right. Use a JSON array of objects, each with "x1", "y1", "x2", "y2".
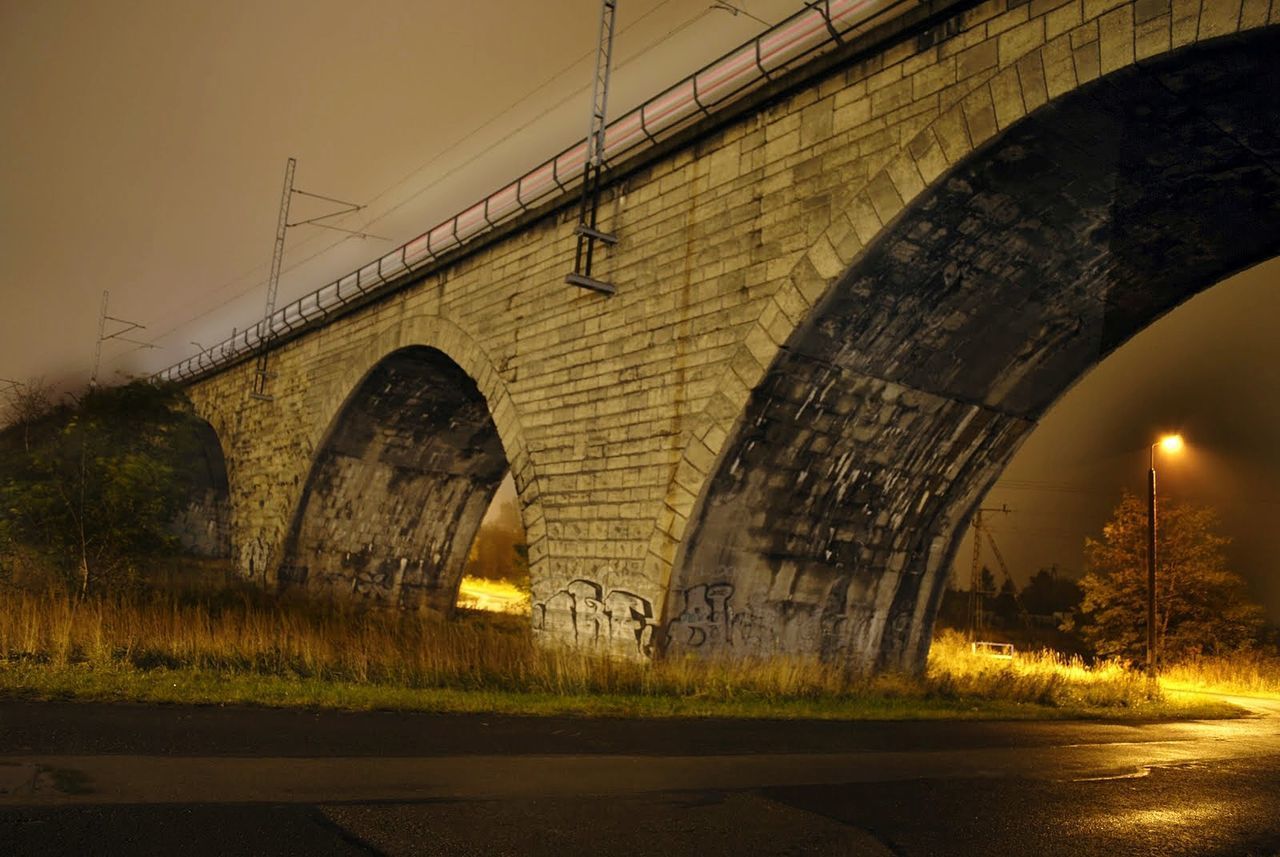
[{"x1": 666, "y1": 28, "x2": 1280, "y2": 669}]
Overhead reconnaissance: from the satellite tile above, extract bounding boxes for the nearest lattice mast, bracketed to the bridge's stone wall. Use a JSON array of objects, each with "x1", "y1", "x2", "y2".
[{"x1": 564, "y1": 0, "x2": 618, "y2": 297}]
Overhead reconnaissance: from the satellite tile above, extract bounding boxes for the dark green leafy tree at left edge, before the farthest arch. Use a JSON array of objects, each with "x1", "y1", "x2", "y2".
[{"x1": 0, "y1": 381, "x2": 198, "y2": 596}]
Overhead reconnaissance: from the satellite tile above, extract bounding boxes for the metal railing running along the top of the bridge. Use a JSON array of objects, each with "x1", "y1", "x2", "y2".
[{"x1": 154, "y1": 0, "x2": 919, "y2": 381}]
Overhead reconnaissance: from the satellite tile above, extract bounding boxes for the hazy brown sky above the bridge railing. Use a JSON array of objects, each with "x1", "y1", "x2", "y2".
[{"x1": 0, "y1": 0, "x2": 801, "y2": 381}]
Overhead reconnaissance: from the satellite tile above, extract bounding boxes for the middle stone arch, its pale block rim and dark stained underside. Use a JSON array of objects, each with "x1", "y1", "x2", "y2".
[{"x1": 276, "y1": 316, "x2": 545, "y2": 614}]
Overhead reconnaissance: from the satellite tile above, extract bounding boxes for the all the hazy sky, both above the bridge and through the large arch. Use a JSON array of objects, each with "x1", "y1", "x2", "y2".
[{"x1": 0, "y1": 0, "x2": 1280, "y2": 619}]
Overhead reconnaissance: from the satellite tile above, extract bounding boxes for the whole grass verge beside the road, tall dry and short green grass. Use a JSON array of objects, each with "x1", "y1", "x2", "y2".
[{"x1": 0, "y1": 591, "x2": 1239, "y2": 720}]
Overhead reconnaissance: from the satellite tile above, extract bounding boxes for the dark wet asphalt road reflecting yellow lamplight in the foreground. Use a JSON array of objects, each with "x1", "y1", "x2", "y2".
[{"x1": 0, "y1": 700, "x2": 1280, "y2": 857}]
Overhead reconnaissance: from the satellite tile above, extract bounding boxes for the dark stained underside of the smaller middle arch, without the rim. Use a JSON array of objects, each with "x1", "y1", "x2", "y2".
[{"x1": 279, "y1": 347, "x2": 508, "y2": 615}]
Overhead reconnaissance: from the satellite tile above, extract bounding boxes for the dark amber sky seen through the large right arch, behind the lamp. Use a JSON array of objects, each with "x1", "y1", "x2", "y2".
[{"x1": 956, "y1": 260, "x2": 1280, "y2": 620}]
